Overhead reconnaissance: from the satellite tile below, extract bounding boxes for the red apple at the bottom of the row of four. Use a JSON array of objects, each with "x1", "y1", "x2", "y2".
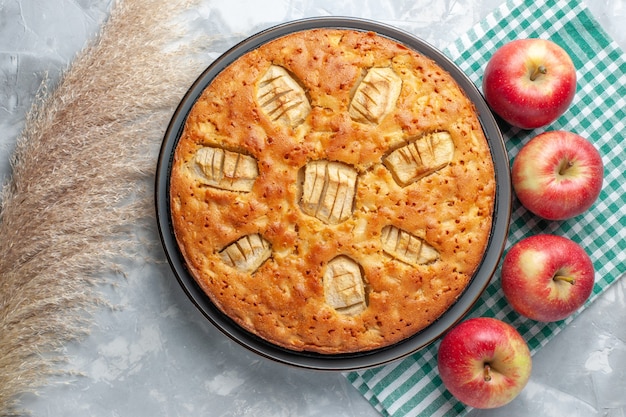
[{"x1": 437, "y1": 317, "x2": 532, "y2": 408}]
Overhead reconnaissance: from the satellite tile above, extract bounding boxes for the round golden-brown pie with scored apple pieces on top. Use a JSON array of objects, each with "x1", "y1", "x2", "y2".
[{"x1": 170, "y1": 29, "x2": 495, "y2": 354}]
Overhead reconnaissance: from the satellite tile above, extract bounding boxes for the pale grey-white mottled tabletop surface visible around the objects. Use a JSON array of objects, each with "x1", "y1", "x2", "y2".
[{"x1": 0, "y1": 0, "x2": 626, "y2": 417}]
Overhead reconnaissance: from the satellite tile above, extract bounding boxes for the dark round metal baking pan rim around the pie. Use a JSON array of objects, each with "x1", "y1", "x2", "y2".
[{"x1": 155, "y1": 17, "x2": 512, "y2": 371}]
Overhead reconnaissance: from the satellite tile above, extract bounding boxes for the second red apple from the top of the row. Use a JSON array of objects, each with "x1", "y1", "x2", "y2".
[{"x1": 511, "y1": 130, "x2": 604, "y2": 220}]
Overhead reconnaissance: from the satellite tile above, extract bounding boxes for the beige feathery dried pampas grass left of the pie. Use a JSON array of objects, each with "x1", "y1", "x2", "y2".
[{"x1": 0, "y1": 0, "x2": 206, "y2": 415}]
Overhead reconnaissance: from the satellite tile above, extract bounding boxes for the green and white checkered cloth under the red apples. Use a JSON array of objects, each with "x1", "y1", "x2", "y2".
[{"x1": 346, "y1": 0, "x2": 626, "y2": 416}]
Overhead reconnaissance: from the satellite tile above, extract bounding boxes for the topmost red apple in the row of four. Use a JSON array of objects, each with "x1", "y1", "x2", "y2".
[{"x1": 483, "y1": 38, "x2": 576, "y2": 129}]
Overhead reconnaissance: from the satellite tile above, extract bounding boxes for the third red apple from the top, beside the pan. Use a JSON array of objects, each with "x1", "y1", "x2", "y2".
[{"x1": 502, "y1": 234, "x2": 595, "y2": 322}]
